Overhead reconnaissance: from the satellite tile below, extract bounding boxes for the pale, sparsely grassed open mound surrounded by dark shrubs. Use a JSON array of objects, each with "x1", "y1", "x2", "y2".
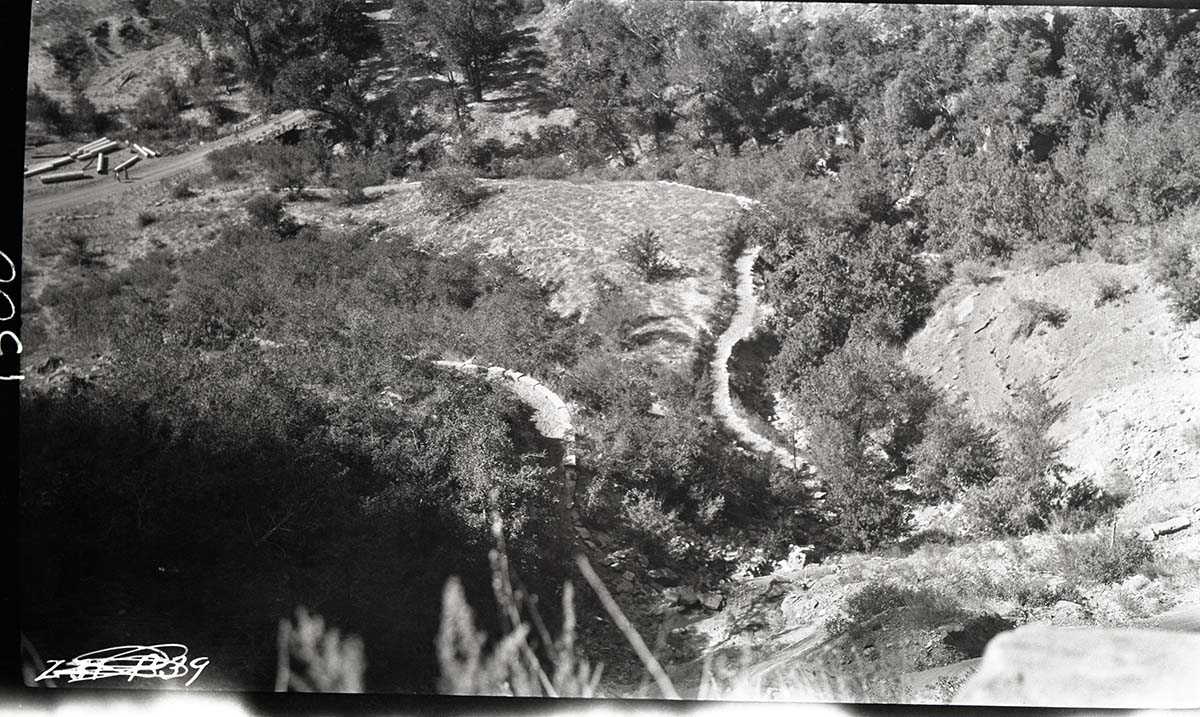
[{"x1": 285, "y1": 180, "x2": 739, "y2": 359}]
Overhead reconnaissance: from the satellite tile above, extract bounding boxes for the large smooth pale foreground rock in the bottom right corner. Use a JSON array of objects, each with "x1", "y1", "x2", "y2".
[{"x1": 954, "y1": 625, "x2": 1200, "y2": 709}]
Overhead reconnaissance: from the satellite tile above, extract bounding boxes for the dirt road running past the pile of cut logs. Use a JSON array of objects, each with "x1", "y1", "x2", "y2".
[{"x1": 24, "y1": 109, "x2": 307, "y2": 222}]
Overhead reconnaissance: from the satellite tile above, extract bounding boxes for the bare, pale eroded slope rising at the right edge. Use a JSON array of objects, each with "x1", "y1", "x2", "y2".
[{"x1": 906, "y1": 261, "x2": 1200, "y2": 529}]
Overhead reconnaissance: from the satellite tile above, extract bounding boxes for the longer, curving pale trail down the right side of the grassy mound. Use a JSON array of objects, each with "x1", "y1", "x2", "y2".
[{"x1": 712, "y1": 247, "x2": 806, "y2": 470}]
